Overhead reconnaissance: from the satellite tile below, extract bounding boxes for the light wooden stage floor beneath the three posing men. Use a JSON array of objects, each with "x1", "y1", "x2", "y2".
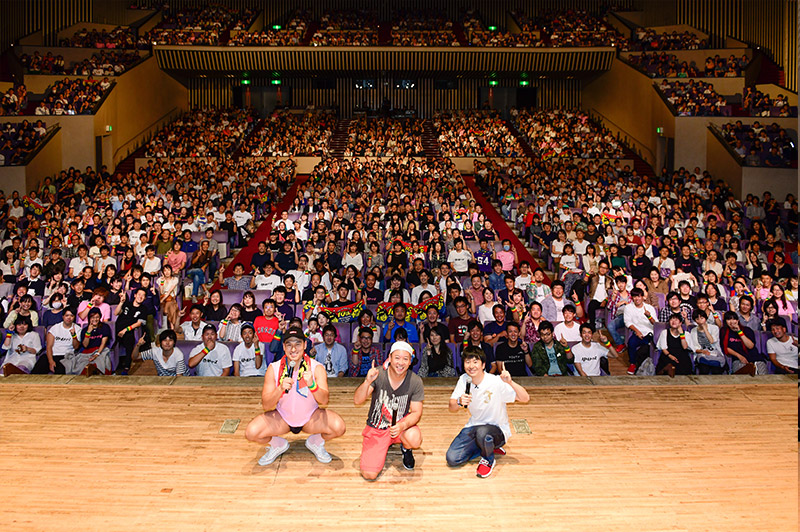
[{"x1": 0, "y1": 377, "x2": 798, "y2": 532}]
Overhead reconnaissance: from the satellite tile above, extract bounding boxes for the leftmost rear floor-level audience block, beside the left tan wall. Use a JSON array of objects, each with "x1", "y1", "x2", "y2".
[{"x1": 145, "y1": 108, "x2": 258, "y2": 157}]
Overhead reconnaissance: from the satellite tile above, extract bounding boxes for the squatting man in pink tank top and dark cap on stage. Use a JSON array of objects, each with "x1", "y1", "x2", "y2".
[{"x1": 245, "y1": 328, "x2": 345, "y2": 466}]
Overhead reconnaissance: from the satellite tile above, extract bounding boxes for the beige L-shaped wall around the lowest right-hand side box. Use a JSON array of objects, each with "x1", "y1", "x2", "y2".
[{"x1": 675, "y1": 116, "x2": 797, "y2": 170}]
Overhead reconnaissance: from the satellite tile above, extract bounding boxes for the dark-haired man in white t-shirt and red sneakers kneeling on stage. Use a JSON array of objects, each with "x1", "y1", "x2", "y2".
[{"x1": 447, "y1": 346, "x2": 530, "y2": 478}]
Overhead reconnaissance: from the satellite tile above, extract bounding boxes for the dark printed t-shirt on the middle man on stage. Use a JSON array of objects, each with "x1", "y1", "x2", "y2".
[{"x1": 367, "y1": 368, "x2": 425, "y2": 429}]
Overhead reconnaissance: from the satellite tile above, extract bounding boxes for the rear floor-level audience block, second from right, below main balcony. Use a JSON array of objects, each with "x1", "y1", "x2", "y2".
[{"x1": 433, "y1": 110, "x2": 523, "y2": 157}]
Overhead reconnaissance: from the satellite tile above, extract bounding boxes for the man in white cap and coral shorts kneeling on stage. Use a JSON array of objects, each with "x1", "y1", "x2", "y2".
[{"x1": 353, "y1": 342, "x2": 425, "y2": 480}]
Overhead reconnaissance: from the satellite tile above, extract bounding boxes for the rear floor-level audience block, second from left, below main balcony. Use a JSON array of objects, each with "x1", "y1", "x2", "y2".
[{"x1": 244, "y1": 110, "x2": 336, "y2": 157}]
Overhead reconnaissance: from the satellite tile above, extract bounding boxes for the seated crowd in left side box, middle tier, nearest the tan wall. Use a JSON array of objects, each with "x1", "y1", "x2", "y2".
[{"x1": 34, "y1": 76, "x2": 113, "y2": 116}]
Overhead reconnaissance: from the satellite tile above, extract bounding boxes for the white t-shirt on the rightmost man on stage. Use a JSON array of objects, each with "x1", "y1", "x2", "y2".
[{"x1": 450, "y1": 373, "x2": 517, "y2": 441}]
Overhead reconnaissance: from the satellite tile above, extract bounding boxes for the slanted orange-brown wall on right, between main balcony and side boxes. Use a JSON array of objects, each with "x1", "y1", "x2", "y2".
[{"x1": 581, "y1": 59, "x2": 675, "y2": 165}]
